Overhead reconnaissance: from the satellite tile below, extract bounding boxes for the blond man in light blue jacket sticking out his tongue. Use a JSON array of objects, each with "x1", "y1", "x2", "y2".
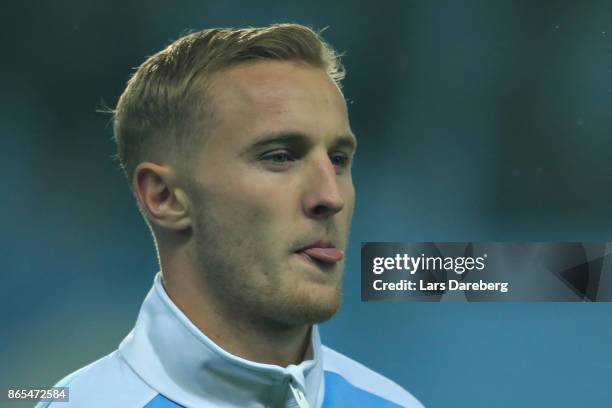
[{"x1": 38, "y1": 24, "x2": 421, "y2": 408}]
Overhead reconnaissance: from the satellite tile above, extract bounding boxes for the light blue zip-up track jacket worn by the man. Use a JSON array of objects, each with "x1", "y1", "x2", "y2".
[{"x1": 37, "y1": 274, "x2": 422, "y2": 408}]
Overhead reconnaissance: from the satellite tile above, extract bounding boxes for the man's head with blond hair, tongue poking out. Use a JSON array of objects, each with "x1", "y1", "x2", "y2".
[{"x1": 115, "y1": 25, "x2": 355, "y2": 325}]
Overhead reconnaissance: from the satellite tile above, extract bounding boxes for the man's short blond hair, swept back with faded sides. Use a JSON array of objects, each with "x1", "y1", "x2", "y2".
[{"x1": 113, "y1": 24, "x2": 345, "y2": 182}]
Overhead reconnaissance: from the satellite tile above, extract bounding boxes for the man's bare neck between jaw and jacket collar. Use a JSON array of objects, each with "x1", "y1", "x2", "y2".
[{"x1": 162, "y1": 264, "x2": 310, "y2": 367}]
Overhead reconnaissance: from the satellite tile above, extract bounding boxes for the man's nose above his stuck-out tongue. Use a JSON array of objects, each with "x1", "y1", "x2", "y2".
[{"x1": 303, "y1": 154, "x2": 344, "y2": 218}]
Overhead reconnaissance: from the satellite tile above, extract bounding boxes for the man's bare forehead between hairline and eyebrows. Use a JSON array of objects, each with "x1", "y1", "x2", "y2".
[{"x1": 207, "y1": 61, "x2": 351, "y2": 147}]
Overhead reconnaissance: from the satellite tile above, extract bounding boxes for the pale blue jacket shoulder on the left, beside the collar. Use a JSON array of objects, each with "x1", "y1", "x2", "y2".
[{"x1": 36, "y1": 351, "x2": 158, "y2": 408}]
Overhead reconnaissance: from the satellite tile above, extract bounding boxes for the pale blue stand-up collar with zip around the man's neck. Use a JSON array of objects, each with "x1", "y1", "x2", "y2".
[{"x1": 119, "y1": 273, "x2": 324, "y2": 407}]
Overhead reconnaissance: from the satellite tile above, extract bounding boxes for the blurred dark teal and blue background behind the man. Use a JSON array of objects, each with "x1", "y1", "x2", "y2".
[{"x1": 0, "y1": 0, "x2": 612, "y2": 408}]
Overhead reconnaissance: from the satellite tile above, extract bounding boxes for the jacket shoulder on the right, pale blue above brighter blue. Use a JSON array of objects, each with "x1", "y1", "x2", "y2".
[{"x1": 322, "y1": 346, "x2": 423, "y2": 408}]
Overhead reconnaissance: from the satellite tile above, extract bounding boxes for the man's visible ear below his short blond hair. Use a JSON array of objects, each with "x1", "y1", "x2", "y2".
[{"x1": 132, "y1": 162, "x2": 191, "y2": 231}]
